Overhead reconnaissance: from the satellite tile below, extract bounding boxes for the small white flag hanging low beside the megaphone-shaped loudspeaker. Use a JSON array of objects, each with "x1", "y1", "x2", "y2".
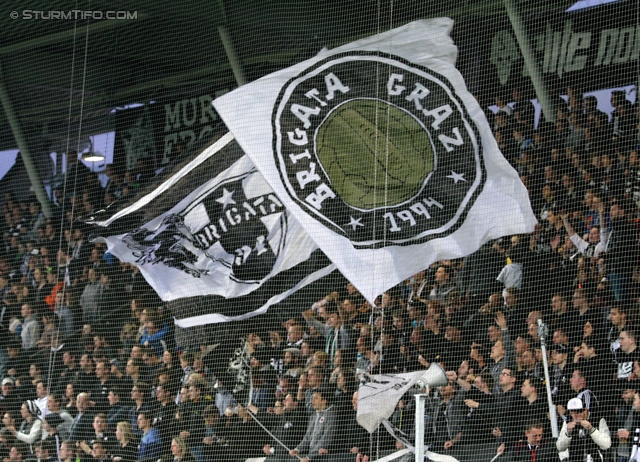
[{"x1": 356, "y1": 371, "x2": 426, "y2": 433}]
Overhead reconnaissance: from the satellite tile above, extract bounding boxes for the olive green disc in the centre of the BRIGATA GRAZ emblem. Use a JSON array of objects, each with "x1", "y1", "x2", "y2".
[{"x1": 316, "y1": 99, "x2": 434, "y2": 210}]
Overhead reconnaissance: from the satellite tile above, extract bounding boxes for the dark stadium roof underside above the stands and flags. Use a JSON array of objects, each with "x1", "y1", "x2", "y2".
[{"x1": 0, "y1": 0, "x2": 574, "y2": 151}]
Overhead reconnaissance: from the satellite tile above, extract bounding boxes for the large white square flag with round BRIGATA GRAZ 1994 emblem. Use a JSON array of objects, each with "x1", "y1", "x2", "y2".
[{"x1": 213, "y1": 18, "x2": 536, "y2": 302}]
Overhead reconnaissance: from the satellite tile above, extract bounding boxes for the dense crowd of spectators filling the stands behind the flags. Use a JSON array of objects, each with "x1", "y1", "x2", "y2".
[{"x1": 0, "y1": 89, "x2": 640, "y2": 462}]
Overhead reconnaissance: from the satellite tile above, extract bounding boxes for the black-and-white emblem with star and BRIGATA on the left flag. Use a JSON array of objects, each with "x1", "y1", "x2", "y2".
[{"x1": 122, "y1": 168, "x2": 288, "y2": 285}]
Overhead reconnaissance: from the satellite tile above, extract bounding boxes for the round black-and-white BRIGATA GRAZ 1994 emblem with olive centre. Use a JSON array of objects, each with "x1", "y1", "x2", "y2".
[{"x1": 273, "y1": 52, "x2": 486, "y2": 248}]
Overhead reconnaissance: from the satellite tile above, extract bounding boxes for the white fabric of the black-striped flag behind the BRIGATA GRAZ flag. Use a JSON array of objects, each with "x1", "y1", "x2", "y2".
[{"x1": 95, "y1": 133, "x2": 334, "y2": 318}]
